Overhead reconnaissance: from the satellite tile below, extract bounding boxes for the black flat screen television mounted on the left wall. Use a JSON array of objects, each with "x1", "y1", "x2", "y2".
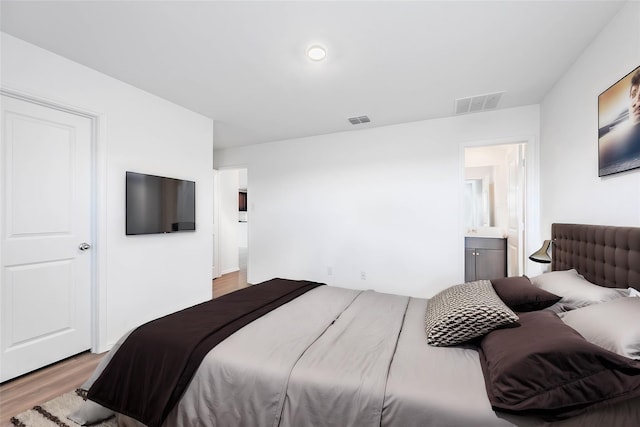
[{"x1": 126, "y1": 172, "x2": 196, "y2": 235}]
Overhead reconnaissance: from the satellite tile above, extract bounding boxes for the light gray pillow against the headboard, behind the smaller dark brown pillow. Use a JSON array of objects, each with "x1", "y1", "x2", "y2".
[{"x1": 531, "y1": 269, "x2": 629, "y2": 309}]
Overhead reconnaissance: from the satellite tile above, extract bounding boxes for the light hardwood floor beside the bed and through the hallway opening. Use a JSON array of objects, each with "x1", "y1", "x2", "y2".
[{"x1": 0, "y1": 270, "x2": 247, "y2": 427}]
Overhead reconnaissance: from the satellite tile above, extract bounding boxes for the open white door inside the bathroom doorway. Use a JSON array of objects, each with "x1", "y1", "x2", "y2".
[{"x1": 507, "y1": 144, "x2": 525, "y2": 276}]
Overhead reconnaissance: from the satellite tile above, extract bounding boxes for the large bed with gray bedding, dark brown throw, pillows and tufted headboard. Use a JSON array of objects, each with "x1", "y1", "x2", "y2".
[{"x1": 72, "y1": 224, "x2": 640, "y2": 427}]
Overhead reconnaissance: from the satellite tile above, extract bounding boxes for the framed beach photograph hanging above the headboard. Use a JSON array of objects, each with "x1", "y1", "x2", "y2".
[{"x1": 598, "y1": 66, "x2": 640, "y2": 176}]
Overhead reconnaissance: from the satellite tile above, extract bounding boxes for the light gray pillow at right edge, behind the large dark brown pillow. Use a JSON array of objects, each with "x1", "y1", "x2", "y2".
[{"x1": 559, "y1": 298, "x2": 640, "y2": 360}]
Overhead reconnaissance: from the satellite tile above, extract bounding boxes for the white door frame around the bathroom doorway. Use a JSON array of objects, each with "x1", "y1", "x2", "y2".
[{"x1": 458, "y1": 135, "x2": 541, "y2": 283}]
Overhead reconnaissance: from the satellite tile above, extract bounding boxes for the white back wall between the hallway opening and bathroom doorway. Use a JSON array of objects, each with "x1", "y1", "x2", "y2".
[{"x1": 214, "y1": 106, "x2": 539, "y2": 296}]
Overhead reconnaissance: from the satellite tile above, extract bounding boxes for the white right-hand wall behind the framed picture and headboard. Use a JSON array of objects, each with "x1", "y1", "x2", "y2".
[{"x1": 540, "y1": 2, "x2": 640, "y2": 234}]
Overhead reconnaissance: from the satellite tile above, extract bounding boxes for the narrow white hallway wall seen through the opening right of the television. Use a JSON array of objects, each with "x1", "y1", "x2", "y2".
[{"x1": 218, "y1": 170, "x2": 240, "y2": 274}]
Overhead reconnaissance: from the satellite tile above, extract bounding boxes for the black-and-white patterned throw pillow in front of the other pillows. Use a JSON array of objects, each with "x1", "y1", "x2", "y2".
[{"x1": 425, "y1": 280, "x2": 518, "y2": 346}]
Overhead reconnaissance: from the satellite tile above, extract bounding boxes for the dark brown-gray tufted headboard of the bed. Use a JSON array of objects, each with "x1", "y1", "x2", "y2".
[{"x1": 551, "y1": 224, "x2": 640, "y2": 290}]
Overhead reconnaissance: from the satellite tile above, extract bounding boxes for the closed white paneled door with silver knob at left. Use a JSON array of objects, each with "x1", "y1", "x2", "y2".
[{"x1": 0, "y1": 95, "x2": 92, "y2": 381}]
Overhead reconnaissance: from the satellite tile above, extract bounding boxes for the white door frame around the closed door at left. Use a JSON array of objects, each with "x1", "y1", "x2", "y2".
[{"x1": 0, "y1": 85, "x2": 108, "y2": 353}]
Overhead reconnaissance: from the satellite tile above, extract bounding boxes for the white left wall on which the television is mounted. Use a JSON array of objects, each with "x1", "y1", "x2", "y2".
[{"x1": 1, "y1": 33, "x2": 213, "y2": 351}]
